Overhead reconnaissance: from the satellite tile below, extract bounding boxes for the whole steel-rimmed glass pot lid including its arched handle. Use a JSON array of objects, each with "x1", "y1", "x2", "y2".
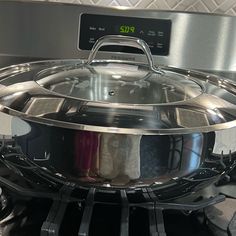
[{"x1": 0, "y1": 36, "x2": 236, "y2": 134}]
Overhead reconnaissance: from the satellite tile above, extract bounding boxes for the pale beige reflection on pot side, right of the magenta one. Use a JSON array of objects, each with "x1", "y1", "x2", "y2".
[{"x1": 99, "y1": 134, "x2": 141, "y2": 185}]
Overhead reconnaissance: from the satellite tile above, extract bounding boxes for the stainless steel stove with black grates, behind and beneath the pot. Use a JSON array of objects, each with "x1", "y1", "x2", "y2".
[{"x1": 0, "y1": 1, "x2": 236, "y2": 236}]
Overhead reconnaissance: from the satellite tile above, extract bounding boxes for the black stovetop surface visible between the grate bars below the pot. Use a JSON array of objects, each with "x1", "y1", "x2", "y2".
[{"x1": 0, "y1": 195, "x2": 214, "y2": 236}]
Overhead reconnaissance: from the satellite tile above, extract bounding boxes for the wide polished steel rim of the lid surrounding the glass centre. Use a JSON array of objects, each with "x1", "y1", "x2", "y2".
[{"x1": 0, "y1": 60, "x2": 236, "y2": 135}]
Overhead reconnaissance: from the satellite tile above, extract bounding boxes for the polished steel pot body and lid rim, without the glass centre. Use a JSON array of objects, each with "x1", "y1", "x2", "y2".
[{"x1": 0, "y1": 57, "x2": 236, "y2": 195}]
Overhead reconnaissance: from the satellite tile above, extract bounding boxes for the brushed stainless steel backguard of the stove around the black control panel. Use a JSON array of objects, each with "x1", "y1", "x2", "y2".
[{"x1": 0, "y1": 1, "x2": 236, "y2": 72}]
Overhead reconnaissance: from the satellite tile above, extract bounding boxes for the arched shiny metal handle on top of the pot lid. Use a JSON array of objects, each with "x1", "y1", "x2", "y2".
[{"x1": 87, "y1": 35, "x2": 162, "y2": 73}]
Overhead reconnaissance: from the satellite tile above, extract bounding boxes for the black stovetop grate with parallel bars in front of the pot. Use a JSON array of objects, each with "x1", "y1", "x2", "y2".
[{"x1": 0, "y1": 185, "x2": 223, "y2": 236}]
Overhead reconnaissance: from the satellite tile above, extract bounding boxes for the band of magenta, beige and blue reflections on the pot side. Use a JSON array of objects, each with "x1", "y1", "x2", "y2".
[{"x1": 72, "y1": 131, "x2": 206, "y2": 186}]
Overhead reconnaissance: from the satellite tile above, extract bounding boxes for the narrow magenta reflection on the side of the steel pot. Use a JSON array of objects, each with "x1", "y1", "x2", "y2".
[{"x1": 75, "y1": 131, "x2": 99, "y2": 182}]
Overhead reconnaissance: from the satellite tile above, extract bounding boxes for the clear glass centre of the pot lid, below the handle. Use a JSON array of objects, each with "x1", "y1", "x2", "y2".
[{"x1": 35, "y1": 62, "x2": 203, "y2": 105}]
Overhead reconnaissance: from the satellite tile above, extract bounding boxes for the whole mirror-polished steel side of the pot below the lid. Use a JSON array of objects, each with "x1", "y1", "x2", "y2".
[{"x1": 0, "y1": 110, "x2": 236, "y2": 199}]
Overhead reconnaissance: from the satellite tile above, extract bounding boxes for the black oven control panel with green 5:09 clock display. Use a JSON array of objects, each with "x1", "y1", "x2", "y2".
[{"x1": 78, "y1": 14, "x2": 171, "y2": 56}]
